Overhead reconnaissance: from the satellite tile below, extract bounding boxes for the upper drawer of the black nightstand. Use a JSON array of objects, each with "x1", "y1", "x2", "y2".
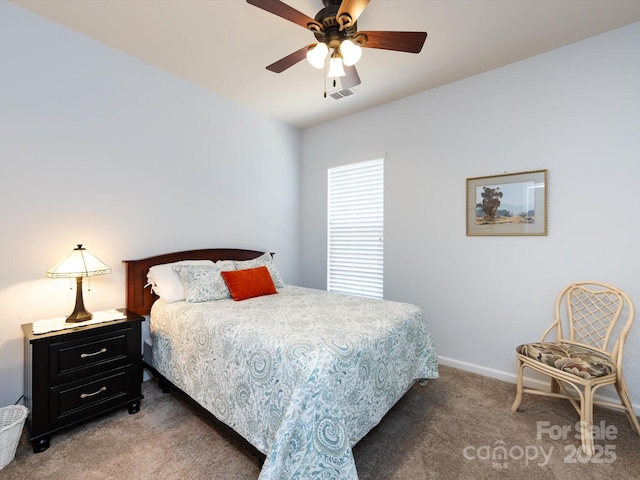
[{"x1": 50, "y1": 329, "x2": 131, "y2": 382}]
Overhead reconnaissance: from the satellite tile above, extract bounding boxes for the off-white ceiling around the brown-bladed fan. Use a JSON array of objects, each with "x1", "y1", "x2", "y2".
[{"x1": 13, "y1": 0, "x2": 640, "y2": 128}]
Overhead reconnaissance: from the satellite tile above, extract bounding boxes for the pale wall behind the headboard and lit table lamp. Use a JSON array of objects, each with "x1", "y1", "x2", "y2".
[{"x1": 0, "y1": 2, "x2": 301, "y2": 406}]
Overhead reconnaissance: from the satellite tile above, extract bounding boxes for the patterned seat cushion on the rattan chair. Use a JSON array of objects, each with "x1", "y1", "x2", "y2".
[{"x1": 516, "y1": 342, "x2": 615, "y2": 379}]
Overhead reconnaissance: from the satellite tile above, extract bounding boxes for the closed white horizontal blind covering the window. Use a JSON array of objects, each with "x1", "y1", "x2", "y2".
[{"x1": 327, "y1": 158, "x2": 384, "y2": 298}]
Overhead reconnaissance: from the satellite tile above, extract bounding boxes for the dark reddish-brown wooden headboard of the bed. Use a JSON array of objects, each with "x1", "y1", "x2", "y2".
[{"x1": 122, "y1": 248, "x2": 264, "y2": 315}]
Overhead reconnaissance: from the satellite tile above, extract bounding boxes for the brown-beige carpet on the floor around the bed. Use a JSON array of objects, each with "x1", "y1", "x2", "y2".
[{"x1": 0, "y1": 367, "x2": 640, "y2": 480}]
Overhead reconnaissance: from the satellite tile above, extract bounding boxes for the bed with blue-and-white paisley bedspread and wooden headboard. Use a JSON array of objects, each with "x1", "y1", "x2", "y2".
[{"x1": 125, "y1": 249, "x2": 438, "y2": 480}]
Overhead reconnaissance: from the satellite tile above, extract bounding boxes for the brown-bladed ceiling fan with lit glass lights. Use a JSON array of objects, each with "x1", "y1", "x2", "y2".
[{"x1": 247, "y1": 0, "x2": 427, "y2": 91}]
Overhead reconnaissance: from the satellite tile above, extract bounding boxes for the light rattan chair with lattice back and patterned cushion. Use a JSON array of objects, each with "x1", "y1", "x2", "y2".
[{"x1": 511, "y1": 282, "x2": 640, "y2": 455}]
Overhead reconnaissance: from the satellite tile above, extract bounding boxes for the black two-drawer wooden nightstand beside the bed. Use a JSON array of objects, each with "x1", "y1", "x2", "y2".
[{"x1": 22, "y1": 309, "x2": 144, "y2": 453}]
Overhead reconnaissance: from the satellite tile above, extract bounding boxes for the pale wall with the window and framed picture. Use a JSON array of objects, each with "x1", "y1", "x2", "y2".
[{"x1": 301, "y1": 23, "x2": 640, "y2": 405}]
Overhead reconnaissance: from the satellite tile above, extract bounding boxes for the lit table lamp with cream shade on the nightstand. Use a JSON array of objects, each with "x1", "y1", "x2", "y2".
[{"x1": 47, "y1": 244, "x2": 111, "y2": 323}]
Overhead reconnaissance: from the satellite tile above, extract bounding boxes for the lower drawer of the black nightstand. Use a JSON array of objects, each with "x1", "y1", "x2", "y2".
[{"x1": 50, "y1": 368, "x2": 132, "y2": 425}]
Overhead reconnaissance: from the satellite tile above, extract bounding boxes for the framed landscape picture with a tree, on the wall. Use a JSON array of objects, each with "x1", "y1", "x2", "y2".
[{"x1": 467, "y1": 170, "x2": 548, "y2": 236}]
